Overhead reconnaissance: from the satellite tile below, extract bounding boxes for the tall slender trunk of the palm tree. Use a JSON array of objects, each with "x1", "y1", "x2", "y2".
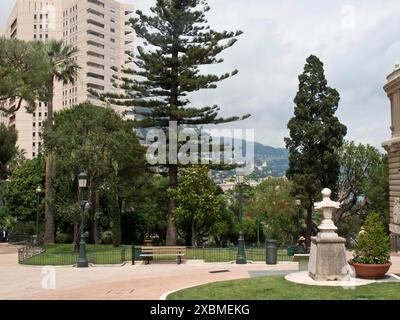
[{"x1": 43, "y1": 79, "x2": 55, "y2": 243}]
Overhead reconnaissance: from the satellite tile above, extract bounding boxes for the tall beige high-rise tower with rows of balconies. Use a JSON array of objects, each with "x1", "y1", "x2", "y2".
[{"x1": 0, "y1": 0, "x2": 133, "y2": 159}]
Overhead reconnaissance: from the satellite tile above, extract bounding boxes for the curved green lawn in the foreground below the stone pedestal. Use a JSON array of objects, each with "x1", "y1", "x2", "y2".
[{"x1": 167, "y1": 276, "x2": 400, "y2": 300}]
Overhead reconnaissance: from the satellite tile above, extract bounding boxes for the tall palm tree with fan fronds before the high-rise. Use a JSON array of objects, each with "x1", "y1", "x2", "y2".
[{"x1": 44, "y1": 40, "x2": 79, "y2": 243}]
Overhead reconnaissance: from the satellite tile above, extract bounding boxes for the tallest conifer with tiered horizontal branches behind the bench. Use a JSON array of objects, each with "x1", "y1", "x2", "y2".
[{"x1": 93, "y1": 0, "x2": 249, "y2": 245}]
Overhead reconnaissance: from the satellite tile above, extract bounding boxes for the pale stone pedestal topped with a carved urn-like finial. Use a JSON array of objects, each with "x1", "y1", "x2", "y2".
[{"x1": 308, "y1": 189, "x2": 350, "y2": 281}]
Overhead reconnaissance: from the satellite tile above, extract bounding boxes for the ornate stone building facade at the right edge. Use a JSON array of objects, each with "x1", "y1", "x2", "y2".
[{"x1": 382, "y1": 65, "x2": 400, "y2": 251}]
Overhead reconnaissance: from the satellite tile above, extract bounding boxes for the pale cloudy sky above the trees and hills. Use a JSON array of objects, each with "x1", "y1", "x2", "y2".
[{"x1": 0, "y1": 0, "x2": 400, "y2": 147}]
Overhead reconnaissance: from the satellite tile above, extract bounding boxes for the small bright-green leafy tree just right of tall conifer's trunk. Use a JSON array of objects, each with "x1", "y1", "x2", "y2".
[{"x1": 169, "y1": 166, "x2": 224, "y2": 246}]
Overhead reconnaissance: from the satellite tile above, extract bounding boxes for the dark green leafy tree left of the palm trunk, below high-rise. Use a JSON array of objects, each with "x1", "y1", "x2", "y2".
[{"x1": 4, "y1": 156, "x2": 45, "y2": 232}]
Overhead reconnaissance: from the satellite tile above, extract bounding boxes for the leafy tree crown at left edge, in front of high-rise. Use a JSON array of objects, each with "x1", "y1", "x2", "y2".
[{"x1": 0, "y1": 37, "x2": 50, "y2": 114}]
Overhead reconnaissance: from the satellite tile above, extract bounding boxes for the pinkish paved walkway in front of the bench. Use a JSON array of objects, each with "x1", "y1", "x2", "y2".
[{"x1": 0, "y1": 248, "x2": 400, "y2": 300}]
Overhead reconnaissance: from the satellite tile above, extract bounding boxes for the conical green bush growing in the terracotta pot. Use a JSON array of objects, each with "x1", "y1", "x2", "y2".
[{"x1": 353, "y1": 213, "x2": 390, "y2": 264}]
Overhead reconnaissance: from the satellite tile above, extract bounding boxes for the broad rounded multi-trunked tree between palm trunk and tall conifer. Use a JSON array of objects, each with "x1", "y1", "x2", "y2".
[{"x1": 43, "y1": 103, "x2": 146, "y2": 245}]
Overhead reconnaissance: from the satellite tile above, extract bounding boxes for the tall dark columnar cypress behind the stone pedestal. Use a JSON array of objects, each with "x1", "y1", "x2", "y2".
[{"x1": 285, "y1": 55, "x2": 347, "y2": 245}]
